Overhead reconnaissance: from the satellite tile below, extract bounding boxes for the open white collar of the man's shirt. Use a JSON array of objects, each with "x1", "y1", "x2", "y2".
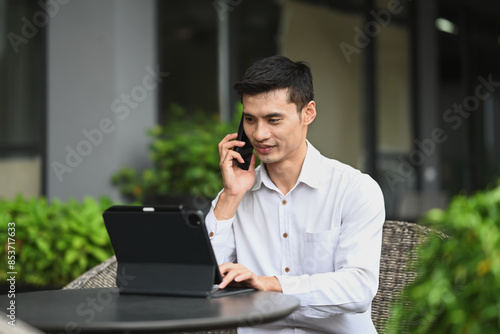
[{"x1": 251, "y1": 140, "x2": 324, "y2": 191}]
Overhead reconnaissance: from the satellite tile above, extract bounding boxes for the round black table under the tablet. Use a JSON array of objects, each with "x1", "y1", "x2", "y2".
[{"x1": 0, "y1": 288, "x2": 299, "y2": 333}]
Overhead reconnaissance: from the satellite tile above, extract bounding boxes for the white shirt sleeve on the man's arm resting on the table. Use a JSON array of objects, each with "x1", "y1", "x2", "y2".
[{"x1": 276, "y1": 174, "x2": 385, "y2": 314}]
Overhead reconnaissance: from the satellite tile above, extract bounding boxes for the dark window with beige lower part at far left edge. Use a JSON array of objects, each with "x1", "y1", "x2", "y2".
[{"x1": 0, "y1": 0, "x2": 47, "y2": 197}]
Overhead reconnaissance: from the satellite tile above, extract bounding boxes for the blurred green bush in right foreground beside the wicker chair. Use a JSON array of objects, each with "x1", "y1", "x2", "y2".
[{"x1": 389, "y1": 185, "x2": 500, "y2": 334}]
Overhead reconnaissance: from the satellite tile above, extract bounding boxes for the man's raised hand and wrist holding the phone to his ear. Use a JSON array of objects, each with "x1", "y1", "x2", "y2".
[{"x1": 214, "y1": 133, "x2": 256, "y2": 220}]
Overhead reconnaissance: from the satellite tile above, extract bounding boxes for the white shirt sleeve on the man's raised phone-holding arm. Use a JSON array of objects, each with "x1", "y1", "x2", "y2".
[{"x1": 205, "y1": 191, "x2": 236, "y2": 264}]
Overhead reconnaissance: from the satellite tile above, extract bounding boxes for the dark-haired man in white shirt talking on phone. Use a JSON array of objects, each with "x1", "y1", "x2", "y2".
[{"x1": 206, "y1": 56, "x2": 385, "y2": 334}]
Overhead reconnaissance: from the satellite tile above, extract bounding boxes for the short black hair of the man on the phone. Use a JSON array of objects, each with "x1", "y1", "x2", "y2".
[{"x1": 233, "y1": 56, "x2": 314, "y2": 112}]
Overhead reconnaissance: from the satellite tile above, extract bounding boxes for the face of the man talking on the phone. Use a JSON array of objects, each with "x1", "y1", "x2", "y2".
[{"x1": 243, "y1": 89, "x2": 316, "y2": 165}]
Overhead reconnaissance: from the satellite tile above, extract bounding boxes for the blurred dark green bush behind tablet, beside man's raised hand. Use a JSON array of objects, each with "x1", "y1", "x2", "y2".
[{"x1": 112, "y1": 104, "x2": 242, "y2": 203}]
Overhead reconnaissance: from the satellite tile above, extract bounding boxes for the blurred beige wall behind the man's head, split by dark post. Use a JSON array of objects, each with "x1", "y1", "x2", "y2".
[{"x1": 279, "y1": 0, "x2": 411, "y2": 170}]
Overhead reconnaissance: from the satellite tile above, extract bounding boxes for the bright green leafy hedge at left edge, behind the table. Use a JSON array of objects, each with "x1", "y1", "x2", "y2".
[{"x1": 0, "y1": 196, "x2": 113, "y2": 286}]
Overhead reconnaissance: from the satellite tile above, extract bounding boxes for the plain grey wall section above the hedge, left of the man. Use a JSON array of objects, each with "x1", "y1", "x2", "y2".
[{"x1": 47, "y1": 0, "x2": 157, "y2": 200}]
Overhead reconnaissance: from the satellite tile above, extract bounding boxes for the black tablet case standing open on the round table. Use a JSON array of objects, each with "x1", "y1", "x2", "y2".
[{"x1": 103, "y1": 205, "x2": 221, "y2": 297}]
